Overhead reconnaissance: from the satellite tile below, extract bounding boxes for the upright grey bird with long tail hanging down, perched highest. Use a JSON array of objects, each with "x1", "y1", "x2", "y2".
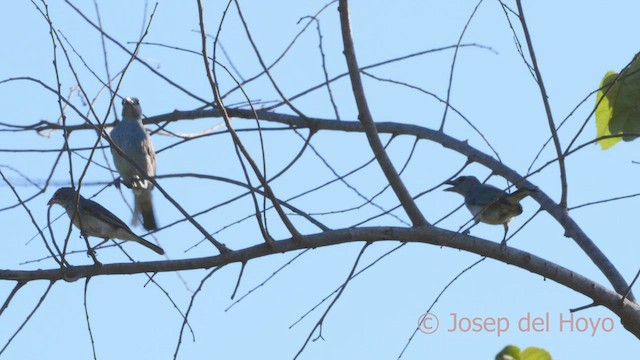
[{"x1": 110, "y1": 97, "x2": 158, "y2": 230}]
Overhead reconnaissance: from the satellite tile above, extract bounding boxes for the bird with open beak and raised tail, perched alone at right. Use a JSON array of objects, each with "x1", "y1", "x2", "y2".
[{"x1": 445, "y1": 176, "x2": 536, "y2": 244}]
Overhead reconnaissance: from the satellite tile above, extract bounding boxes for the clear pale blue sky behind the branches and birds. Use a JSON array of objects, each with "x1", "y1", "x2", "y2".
[{"x1": 0, "y1": 0, "x2": 640, "y2": 359}]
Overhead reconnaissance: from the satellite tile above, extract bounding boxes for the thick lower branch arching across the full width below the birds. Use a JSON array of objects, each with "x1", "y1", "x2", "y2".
[{"x1": 0, "y1": 226, "x2": 640, "y2": 338}]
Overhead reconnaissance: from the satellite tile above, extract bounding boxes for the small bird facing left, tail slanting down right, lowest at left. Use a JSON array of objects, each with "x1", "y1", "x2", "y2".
[{"x1": 47, "y1": 187, "x2": 164, "y2": 255}]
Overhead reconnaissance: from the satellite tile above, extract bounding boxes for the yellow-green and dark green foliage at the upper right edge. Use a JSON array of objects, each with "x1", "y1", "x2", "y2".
[{"x1": 596, "y1": 55, "x2": 640, "y2": 150}]
